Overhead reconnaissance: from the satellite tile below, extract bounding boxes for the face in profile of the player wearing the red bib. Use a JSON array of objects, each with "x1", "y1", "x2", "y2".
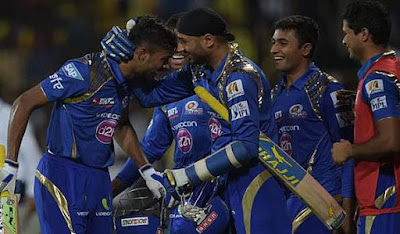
[{"x1": 342, "y1": 20, "x2": 362, "y2": 60}]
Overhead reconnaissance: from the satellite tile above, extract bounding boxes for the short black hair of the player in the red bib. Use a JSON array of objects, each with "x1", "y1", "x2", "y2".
[{"x1": 342, "y1": 0, "x2": 392, "y2": 46}]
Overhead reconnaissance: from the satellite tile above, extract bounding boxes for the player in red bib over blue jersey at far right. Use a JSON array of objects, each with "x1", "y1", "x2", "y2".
[{"x1": 332, "y1": 1, "x2": 400, "y2": 234}]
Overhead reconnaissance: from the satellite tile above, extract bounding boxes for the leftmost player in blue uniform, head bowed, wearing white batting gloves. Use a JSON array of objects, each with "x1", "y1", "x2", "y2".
[{"x1": 0, "y1": 17, "x2": 177, "y2": 233}]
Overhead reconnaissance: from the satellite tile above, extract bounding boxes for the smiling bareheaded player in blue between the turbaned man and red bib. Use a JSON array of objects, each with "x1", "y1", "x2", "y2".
[{"x1": 271, "y1": 15, "x2": 354, "y2": 234}]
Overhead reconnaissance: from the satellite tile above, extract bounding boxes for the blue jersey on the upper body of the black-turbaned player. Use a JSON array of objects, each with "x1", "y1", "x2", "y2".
[{"x1": 135, "y1": 54, "x2": 277, "y2": 158}]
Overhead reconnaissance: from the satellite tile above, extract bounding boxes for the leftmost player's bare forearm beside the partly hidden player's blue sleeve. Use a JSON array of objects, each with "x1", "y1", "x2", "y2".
[{"x1": 114, "y1": 108, "x2": 149, "y2": 168}]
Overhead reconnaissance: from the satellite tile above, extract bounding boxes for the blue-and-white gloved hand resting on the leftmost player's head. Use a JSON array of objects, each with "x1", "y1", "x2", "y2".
[{"x1": 100, "y1": 19, "x2": 136, "y2": 63}]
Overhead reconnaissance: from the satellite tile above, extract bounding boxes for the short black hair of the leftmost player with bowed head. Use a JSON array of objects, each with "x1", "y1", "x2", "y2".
[{"x1": 129, "y1": 16, "x2": 177, "y2": 53}]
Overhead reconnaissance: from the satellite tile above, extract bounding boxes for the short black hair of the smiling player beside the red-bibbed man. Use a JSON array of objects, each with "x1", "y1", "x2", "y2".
[{"x1": 274, "y1": 15, "x2": 319, "y2": 57}]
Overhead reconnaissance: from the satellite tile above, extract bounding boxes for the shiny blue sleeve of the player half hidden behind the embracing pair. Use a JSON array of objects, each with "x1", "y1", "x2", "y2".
[{"x1": 140, "y1": 107, "x2": 173, "y2": 162}]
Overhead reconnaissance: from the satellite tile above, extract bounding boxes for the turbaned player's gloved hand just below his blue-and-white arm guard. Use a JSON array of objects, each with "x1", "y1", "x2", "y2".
[{"x1": 163, "y1": 168, "x2": 191, "y2": 200}]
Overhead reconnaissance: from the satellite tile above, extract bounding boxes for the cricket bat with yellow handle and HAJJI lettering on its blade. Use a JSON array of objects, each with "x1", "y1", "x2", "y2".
[{"x1": 194, "y1": 87, "x2": 346, "y2": 230}]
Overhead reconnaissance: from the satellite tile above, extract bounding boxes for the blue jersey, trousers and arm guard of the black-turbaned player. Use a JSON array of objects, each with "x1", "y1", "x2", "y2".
[{"x1": 135, "y1": 47, "x2": 291, "y2": 233}]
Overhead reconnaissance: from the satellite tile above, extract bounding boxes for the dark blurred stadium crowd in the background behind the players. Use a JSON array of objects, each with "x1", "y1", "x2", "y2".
[{"x1": 0, "y1": 0, "x2": 400, "y2": 233}]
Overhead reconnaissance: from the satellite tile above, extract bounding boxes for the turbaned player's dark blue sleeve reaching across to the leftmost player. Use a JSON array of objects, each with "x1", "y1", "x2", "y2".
[{"x1": 133, "y1": 66, "x2": 194, "y2": 108}]
